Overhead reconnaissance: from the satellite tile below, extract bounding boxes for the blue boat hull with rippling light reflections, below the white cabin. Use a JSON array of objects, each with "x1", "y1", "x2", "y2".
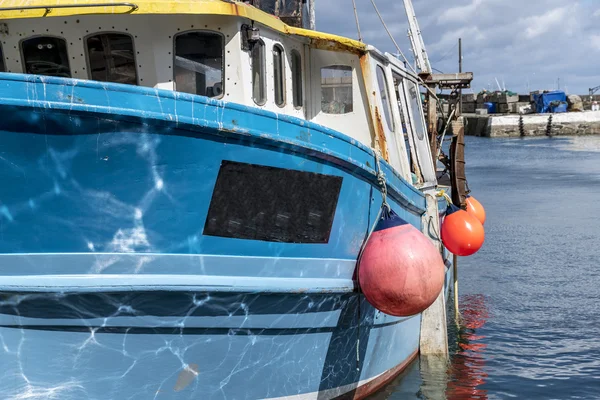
[{"x1": 0, "y1": 74, "x2": 446, "y2": 399}]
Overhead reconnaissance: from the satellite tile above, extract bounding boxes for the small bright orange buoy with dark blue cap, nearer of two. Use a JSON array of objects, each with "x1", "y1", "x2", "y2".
[{"x1": 441, "y1": 204, "x2": 485, "y2": 257}]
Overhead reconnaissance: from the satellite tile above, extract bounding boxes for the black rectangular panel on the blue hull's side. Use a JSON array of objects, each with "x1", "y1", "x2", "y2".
[{"x1": 204, "y1": 161, "x2": 342, "y2": 243}]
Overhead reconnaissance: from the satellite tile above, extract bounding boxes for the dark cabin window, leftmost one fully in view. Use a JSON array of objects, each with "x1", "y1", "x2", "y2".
[{"x1": 21, "y1": 36, "x2": 71, "y2": 78}]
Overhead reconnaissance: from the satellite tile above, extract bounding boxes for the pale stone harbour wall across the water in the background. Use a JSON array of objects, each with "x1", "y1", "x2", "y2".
[{"x1": 463, "y1": 111, "x2": 600, "y2": 137}]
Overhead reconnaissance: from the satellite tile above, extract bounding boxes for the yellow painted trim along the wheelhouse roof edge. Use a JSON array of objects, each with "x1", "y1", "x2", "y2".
[{"x1": 0, "y1": 0, "x2": 366, "y2": 53}]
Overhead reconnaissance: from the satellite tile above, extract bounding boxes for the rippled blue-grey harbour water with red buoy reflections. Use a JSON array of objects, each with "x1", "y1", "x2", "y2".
[{"x1": 372, "y1": 136, "x2": 600, "y2": 400}]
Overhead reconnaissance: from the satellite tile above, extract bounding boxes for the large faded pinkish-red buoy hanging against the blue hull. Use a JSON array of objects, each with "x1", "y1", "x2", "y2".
[{"x1": 358, "y1": 209, "x2": 445, "y2": 317}]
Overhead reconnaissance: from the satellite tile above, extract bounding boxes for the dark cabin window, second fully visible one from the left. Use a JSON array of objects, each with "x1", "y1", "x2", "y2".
[{"x1": 85, "y1": 33, "x2": 137, "y2": 85}]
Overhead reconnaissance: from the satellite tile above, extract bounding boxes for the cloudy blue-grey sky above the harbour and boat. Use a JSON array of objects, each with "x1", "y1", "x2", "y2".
[{"x1": 315, "y1": 0, "x2": 600, "y2": 94}]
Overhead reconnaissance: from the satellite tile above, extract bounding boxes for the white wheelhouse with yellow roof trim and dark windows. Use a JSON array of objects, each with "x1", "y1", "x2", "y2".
[{"x1": 0, "y1": 0, "x2": 436, "y2": 189}]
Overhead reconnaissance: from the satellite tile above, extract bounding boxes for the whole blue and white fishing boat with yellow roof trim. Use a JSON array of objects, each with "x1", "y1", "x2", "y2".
[{"x1": 0, "y1": 0, "x2": 462, "y2": 400}]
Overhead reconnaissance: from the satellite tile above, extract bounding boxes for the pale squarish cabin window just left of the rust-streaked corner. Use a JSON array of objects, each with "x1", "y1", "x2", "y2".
[{"x1": 321, "y1": 65, "x2": 353, "y2": 114}]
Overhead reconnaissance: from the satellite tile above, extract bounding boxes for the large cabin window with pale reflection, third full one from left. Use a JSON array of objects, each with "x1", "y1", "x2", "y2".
[{"x1": 173, "y1": 32, "x2": 224, "y2": 97}]
